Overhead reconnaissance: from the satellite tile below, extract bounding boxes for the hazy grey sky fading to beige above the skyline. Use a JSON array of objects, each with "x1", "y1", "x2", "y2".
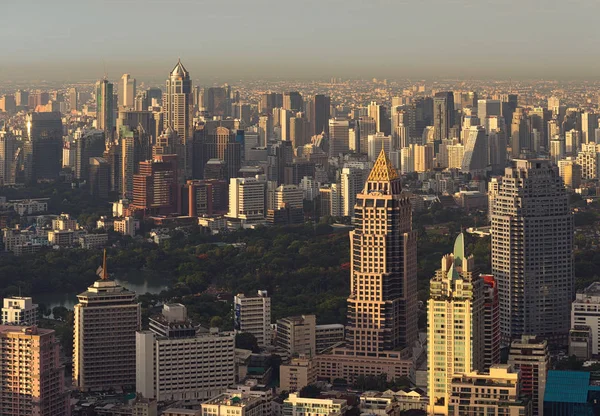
[{"x1": 0, "y1": 0, "x2": 600, "y2": 81}]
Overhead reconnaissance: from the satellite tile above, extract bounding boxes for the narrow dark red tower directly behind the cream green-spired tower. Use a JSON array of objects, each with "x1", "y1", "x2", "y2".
[{"x1": 480, "y1": 274, "x2": 500, "y2": 371}]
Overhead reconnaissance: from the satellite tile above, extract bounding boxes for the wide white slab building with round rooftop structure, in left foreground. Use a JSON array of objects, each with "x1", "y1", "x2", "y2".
[{"x1": 134, "y1": 303, "x2": 235, "y2": 404}]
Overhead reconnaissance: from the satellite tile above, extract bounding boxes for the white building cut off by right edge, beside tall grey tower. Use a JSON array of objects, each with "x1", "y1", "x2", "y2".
[{"x1": 571, "y1": 282, "x2": 600, "y2": 355}]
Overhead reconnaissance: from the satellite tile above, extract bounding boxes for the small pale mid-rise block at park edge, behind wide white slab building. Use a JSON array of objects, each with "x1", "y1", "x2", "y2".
[{"x1": 233, "y1": 290, "x2": 271, "y2": 347}]
